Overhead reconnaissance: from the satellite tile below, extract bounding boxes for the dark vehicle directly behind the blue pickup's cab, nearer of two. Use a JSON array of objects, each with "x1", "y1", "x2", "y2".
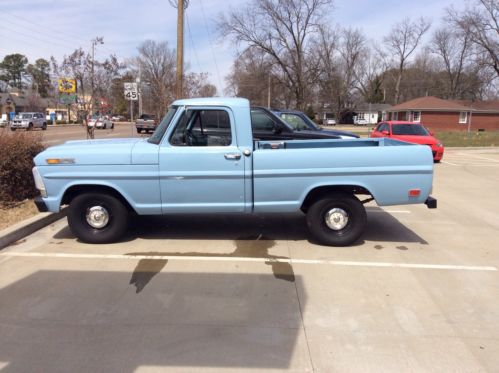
[{"x1": 250, "y1": 106, "x2": 355, "y2": 140}]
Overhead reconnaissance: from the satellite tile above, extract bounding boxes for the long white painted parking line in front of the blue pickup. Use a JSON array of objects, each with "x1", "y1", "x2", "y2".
[{"x1": 0, "y1": 252, "x2": 497, "y2": 271}]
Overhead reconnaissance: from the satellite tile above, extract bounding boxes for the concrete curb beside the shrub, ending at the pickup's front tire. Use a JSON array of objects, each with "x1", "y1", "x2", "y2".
[{"x1": 0, "y1": 209, "x2": 66, "y2": 250}]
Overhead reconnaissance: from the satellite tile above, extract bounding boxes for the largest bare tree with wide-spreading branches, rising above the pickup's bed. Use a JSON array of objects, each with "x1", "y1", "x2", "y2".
[{"x1": 218, "y1": 0, "x2": 332, "y2": 108}]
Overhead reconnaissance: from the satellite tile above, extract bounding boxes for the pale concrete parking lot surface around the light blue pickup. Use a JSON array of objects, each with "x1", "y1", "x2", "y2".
[{"x1": 0, "y1": 148, "x2": 499, "y2": 372}]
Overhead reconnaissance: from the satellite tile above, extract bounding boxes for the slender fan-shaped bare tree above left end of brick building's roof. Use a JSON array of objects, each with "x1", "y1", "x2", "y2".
[{"x1": 383, "y1": 17, "x2": 430, "y2": 104}]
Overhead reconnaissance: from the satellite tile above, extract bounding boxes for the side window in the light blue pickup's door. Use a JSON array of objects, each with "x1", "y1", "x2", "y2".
[{"x1": 170, "y1": 110, "x2": 232, "y2": 146}]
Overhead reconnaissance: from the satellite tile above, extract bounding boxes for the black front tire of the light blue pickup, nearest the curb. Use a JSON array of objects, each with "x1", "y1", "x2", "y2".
[{"x1": 68, "y1": 193, "x2": 130, "y2": 244}]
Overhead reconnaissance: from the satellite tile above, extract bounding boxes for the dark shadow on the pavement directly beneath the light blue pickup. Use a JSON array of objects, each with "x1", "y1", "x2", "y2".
[{"x1": 54, "y1": 207, "x2": 428, "y2": 246}]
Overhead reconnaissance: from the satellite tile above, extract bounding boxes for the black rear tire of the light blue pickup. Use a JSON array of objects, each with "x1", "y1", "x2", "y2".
[{"x1": 307, "y1": 194, "x2": 367, "y2": 246}]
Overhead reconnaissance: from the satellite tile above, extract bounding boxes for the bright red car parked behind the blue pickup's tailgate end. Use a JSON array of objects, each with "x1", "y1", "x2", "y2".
[{"x1": 371, "y1": 121, "x2": 444, "y2": 162}]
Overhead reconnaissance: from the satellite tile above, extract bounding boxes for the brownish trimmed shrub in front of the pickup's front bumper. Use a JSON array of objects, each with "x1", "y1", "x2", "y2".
[{"x1": 0, "y1": 131, "x2": 45, "y2": 206}]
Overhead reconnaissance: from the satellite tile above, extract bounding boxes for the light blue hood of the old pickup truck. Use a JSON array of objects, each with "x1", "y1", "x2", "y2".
[{"x1": 34, "y1": 138, "x2": 145, "y2": 166}]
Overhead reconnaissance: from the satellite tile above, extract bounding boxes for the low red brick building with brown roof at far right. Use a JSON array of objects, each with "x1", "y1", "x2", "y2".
[{"x1": 386, "y1": 96, "x2": 499, "y2": 131}]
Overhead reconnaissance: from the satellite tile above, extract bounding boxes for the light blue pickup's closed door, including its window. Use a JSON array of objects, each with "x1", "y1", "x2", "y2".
[{"x1": 159, "y1": 107, "x2": 247, "y2": 213}]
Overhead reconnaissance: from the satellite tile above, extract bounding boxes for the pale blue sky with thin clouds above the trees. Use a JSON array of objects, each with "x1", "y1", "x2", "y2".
[{"x1": 0, "y1": 0, "x2": 468, "y2": 95}]
